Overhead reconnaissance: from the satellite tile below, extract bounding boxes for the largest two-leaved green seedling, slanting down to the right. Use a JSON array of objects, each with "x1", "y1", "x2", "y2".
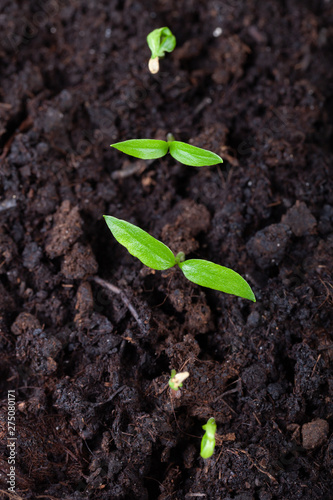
[{"x1": 104, "y1": 215, "x2": 256, "y2": 302}]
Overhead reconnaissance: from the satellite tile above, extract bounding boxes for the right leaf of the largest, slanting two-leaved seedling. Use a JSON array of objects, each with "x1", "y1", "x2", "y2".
[{"x1": 178, "y1": 259, "x2": 256, "y2": 302}]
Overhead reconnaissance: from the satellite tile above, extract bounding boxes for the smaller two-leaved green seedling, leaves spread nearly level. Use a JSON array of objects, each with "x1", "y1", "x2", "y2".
[{"x1": 111, "y1": 134, "x2": 223, "y2": 167}]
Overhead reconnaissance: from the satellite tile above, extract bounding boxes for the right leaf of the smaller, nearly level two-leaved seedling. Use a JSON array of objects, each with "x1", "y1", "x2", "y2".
[{"x1": 169, "y1": 141, "x2": 223, "y2": 167}]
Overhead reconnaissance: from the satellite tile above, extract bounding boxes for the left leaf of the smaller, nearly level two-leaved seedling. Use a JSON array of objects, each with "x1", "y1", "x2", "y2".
[{"x1": 110, "y1": 139, "x2": 169, "y2": 160}]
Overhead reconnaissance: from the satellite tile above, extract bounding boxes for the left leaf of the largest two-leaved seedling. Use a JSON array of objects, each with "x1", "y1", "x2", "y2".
[{"x1": 104, "y1": 215, "x2": 176, "y2": 271}]
